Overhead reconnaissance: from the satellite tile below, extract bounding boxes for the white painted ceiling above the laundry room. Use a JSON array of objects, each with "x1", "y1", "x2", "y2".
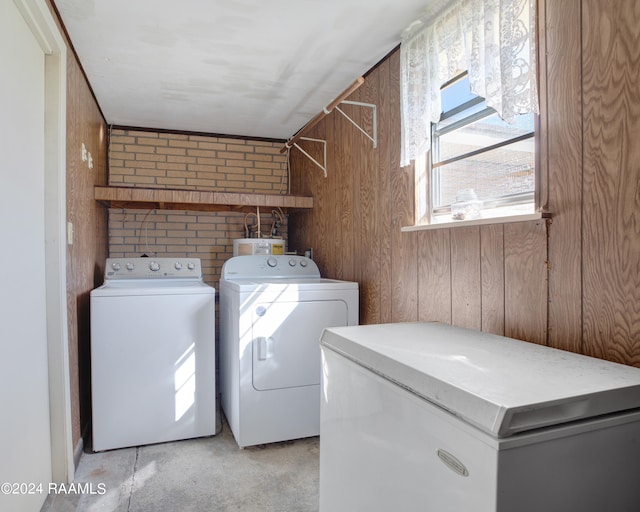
[{"x1": 54, "y1": 0, "x2": 446, "y2": 139}]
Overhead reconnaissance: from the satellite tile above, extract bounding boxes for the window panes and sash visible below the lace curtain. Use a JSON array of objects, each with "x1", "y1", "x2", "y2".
[{"x1": 428, "y1": 73, "x2": 536, "y2": 224}]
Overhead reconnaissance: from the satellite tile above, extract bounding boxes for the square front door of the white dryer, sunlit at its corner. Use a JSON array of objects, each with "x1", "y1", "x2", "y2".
[{"x1": 252, "y1": 300, "x2": 348, "y2": 391}]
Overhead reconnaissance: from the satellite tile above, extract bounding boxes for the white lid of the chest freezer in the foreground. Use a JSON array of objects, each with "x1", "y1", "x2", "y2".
[{"x1": 321, "y1": 322, "x2": 640, "y2": 437}]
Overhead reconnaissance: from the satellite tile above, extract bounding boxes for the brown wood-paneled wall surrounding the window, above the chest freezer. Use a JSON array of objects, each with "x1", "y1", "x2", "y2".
[{"x1": 289, "y1": 0, "x2": 640, "y2": 366}]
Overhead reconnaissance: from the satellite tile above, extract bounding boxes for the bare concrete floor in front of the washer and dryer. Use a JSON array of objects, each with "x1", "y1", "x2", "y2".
[{"x1": 41, "y1": 416, "x2": 319, "y2": 512}]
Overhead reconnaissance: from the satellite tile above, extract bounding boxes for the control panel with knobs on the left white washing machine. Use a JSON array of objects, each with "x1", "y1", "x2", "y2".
[{"x1": 104, "y1": 258, "x2": 202, "y2": 280}]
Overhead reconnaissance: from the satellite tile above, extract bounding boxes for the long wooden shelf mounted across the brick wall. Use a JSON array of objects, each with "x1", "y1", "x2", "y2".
[{"x1": 94, "y1": 186, "x2": 313, "y2": 212}]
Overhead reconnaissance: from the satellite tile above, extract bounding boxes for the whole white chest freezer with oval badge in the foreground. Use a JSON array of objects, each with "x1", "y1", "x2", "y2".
[{"x1": 320, "y1": 323, "x2": 640, "y2": 512}]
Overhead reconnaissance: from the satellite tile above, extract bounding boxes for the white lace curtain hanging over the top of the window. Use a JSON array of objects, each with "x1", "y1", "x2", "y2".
[{"x1": 400, "y1": 0, "x2": 538, "y2": 166}]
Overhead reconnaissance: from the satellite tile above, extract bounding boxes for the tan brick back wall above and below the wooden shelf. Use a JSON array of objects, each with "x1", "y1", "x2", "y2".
[{"x1": 109, "y1": 129, "x2": 288, "y2": 288}]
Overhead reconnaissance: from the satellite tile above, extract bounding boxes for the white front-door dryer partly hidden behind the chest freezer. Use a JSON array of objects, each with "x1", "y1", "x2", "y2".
[{"x1": 220, "y1": 255, "x2": 358, "y2": 447}]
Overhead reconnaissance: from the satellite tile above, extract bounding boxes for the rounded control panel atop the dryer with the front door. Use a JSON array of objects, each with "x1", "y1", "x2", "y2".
[{"x1": 222, "y1": 254, "x2": 320, "y2": 279}]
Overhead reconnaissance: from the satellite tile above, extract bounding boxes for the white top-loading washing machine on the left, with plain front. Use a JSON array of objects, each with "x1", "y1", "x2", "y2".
[{"x1": 91, "y1": 258, "x2": 216, "y2": 451}]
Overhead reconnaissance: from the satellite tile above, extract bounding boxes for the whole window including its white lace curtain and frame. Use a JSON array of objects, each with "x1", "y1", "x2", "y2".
[{"x1": 400, "y1": 0, "x2": 543, "y2": 231}]
